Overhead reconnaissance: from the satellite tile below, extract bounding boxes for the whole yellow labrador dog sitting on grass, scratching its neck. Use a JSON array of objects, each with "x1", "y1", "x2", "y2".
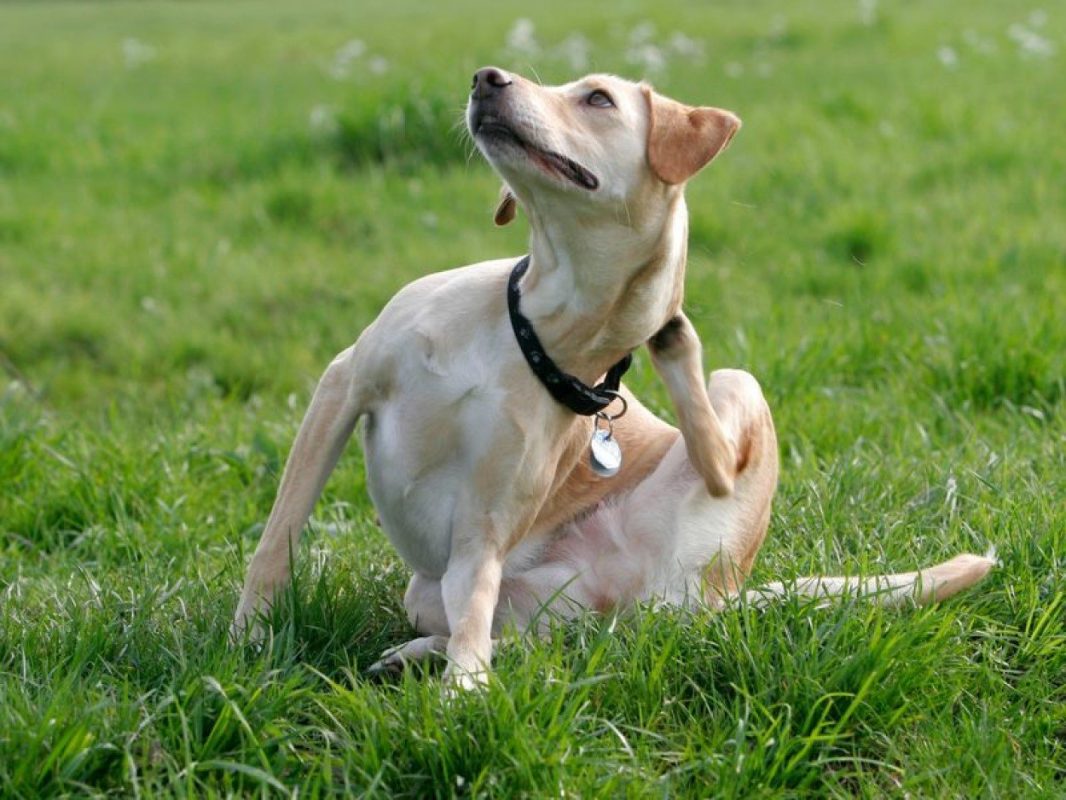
[{"x1": 233, "y1": 67, "x2": 991, "y2": 686}]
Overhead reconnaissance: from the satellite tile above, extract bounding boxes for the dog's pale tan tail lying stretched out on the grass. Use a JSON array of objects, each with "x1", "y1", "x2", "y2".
[{"x1": 742, "y1": 550, "x2": 997, "y2": 606}]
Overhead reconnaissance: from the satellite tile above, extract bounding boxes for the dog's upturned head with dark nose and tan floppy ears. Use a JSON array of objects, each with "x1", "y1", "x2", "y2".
[{"x1": 467, "y1": 67, "x2": 740, "y2": 224}]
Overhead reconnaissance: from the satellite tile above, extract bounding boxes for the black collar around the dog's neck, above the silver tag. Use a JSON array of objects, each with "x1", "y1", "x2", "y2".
[{"x1": 507, "y1": 256, "x2": 633, "y2": 417}]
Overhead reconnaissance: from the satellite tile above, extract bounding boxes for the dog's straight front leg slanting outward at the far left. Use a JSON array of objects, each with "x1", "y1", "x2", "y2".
[{"x1": 231, "y1": 345, "x2": 362, "y2": 638}]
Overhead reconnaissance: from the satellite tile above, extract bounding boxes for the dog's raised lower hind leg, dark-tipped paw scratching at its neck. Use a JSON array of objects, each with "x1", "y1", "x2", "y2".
[{"x1": 648, "y1": 313, "x2": 737, "y2": 497}]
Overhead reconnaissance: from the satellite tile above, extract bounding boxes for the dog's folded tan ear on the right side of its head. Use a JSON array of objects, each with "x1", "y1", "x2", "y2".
[{"x1": 644, "y1": 86, "x2": 740, "y2": 183}]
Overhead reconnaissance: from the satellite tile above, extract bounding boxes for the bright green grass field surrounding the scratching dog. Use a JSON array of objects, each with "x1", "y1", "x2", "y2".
[{"x1": 0, "y1": 0, "x2": 1066, "y2": 798}]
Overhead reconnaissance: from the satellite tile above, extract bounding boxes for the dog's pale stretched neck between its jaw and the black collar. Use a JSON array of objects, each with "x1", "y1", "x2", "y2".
[{"x1": 521, "y1": 191, "x2": 689, "y2": 383}]
